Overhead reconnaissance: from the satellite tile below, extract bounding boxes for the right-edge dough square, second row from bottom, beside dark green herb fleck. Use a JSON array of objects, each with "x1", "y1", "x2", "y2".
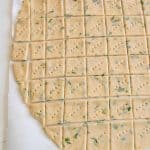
[{"x1": 133, "y1": 98, "x2": 150, "y2": 119}]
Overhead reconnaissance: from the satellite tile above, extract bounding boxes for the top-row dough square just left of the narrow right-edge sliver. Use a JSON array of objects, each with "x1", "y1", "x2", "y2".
[{"x1": 122, "y1": 0, "x2": 142, "y2": 15}]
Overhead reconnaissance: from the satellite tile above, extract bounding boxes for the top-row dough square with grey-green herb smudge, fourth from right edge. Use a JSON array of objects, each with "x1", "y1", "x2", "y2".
[{"x1": 84, "y1": 0, "x2": 104, "y2": 15}]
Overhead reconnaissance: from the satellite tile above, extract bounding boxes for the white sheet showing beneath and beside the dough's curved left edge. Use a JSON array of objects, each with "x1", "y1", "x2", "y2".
[{"x1": 8, "y1": 0, "x2": 57, "y2": 150}]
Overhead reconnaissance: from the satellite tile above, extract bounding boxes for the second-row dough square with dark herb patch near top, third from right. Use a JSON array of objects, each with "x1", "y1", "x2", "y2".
[{"x1": 106, "y1": 16, "x2": 125, "y2": 36}]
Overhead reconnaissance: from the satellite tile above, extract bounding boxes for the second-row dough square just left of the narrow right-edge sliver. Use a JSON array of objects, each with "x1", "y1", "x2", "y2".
[{"x1": 125, "y1": 16, "x2": 145, "y2": 35}]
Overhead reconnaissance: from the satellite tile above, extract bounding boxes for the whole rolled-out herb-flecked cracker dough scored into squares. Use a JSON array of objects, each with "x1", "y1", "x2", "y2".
[{"x1": 11, "y1": 0, "x2": 150, "y2": 150}]
